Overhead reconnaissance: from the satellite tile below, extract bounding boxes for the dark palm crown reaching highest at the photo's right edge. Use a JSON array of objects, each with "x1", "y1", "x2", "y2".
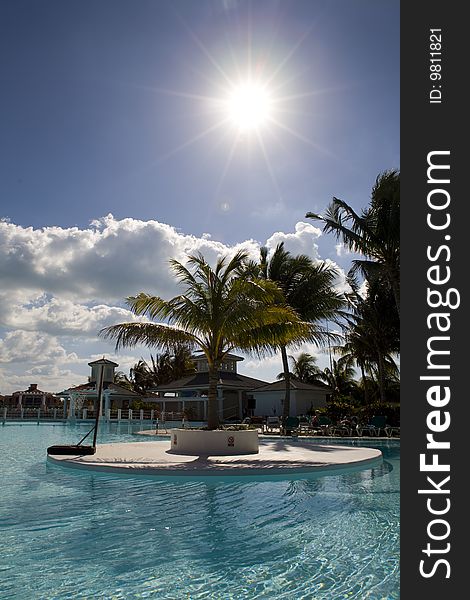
[{"x1": 305, "y1": 170, "x2": 400, "y2": 314}]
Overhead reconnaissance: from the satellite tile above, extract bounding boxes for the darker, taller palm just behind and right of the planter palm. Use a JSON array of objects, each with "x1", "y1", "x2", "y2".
[{"x1": 255, "y1": 243, "x2": 344, "y2": 418}]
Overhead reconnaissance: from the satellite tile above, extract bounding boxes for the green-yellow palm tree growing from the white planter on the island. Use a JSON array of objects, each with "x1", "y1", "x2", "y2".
[{"x1": 100, "y1": 252, "x2": 311, "y2": 429}]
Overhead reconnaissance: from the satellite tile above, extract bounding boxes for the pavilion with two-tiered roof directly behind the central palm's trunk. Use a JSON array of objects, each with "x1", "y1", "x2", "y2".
[{"x1": 151, "y1": 354, "x2": 267, "y2": 421}]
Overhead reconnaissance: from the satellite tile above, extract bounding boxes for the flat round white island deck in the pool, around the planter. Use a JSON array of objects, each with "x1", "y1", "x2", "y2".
[{"x1": 48, "y1": 438, "x2": 382, "y2": 477}]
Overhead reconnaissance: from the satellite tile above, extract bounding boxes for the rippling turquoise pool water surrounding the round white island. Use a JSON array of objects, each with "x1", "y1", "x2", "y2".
[{"x1": 0, "y1": 424, "x2": 400, "y2": 600}]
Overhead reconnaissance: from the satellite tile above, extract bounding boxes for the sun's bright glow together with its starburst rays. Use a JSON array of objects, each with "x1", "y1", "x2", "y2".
[{"x1": 151, "y1": 27, "x2": 331, "y2": 197}]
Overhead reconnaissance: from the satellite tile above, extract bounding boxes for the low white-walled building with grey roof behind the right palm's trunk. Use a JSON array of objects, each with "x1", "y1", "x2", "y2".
[{"x1": 250, "y1": 379, "x2": 331, "y2": 417}]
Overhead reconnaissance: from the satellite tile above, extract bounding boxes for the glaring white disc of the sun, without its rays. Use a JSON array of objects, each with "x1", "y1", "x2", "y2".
[{"x1": 226, "y1": 81, "x2": 273, "y2": 132}]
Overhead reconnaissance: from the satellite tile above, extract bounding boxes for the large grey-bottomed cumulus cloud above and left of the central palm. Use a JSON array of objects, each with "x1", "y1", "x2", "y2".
[{"x1": 0, "y1": 215, "x2": 259, "y2": 302}]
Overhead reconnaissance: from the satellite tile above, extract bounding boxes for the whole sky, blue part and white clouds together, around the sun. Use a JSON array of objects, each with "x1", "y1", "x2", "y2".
[{"x1": 0, "y1": 0, "x2": 399, "y2": 393}]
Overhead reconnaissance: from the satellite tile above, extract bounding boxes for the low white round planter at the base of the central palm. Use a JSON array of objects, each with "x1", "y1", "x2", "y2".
[{"x1": 171, "y1": 429, "x2": 259, "y2": 456}]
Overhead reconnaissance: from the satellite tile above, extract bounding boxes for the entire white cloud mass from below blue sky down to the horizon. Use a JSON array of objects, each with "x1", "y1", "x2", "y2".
[{"x1": 0, "y1": 214, "x2": 345, "y2": 393}]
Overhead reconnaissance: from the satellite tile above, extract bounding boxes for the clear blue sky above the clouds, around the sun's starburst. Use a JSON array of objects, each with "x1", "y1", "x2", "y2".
[{"x1": 0, "y1": 0, "x2": 399, "y2": 254}]
